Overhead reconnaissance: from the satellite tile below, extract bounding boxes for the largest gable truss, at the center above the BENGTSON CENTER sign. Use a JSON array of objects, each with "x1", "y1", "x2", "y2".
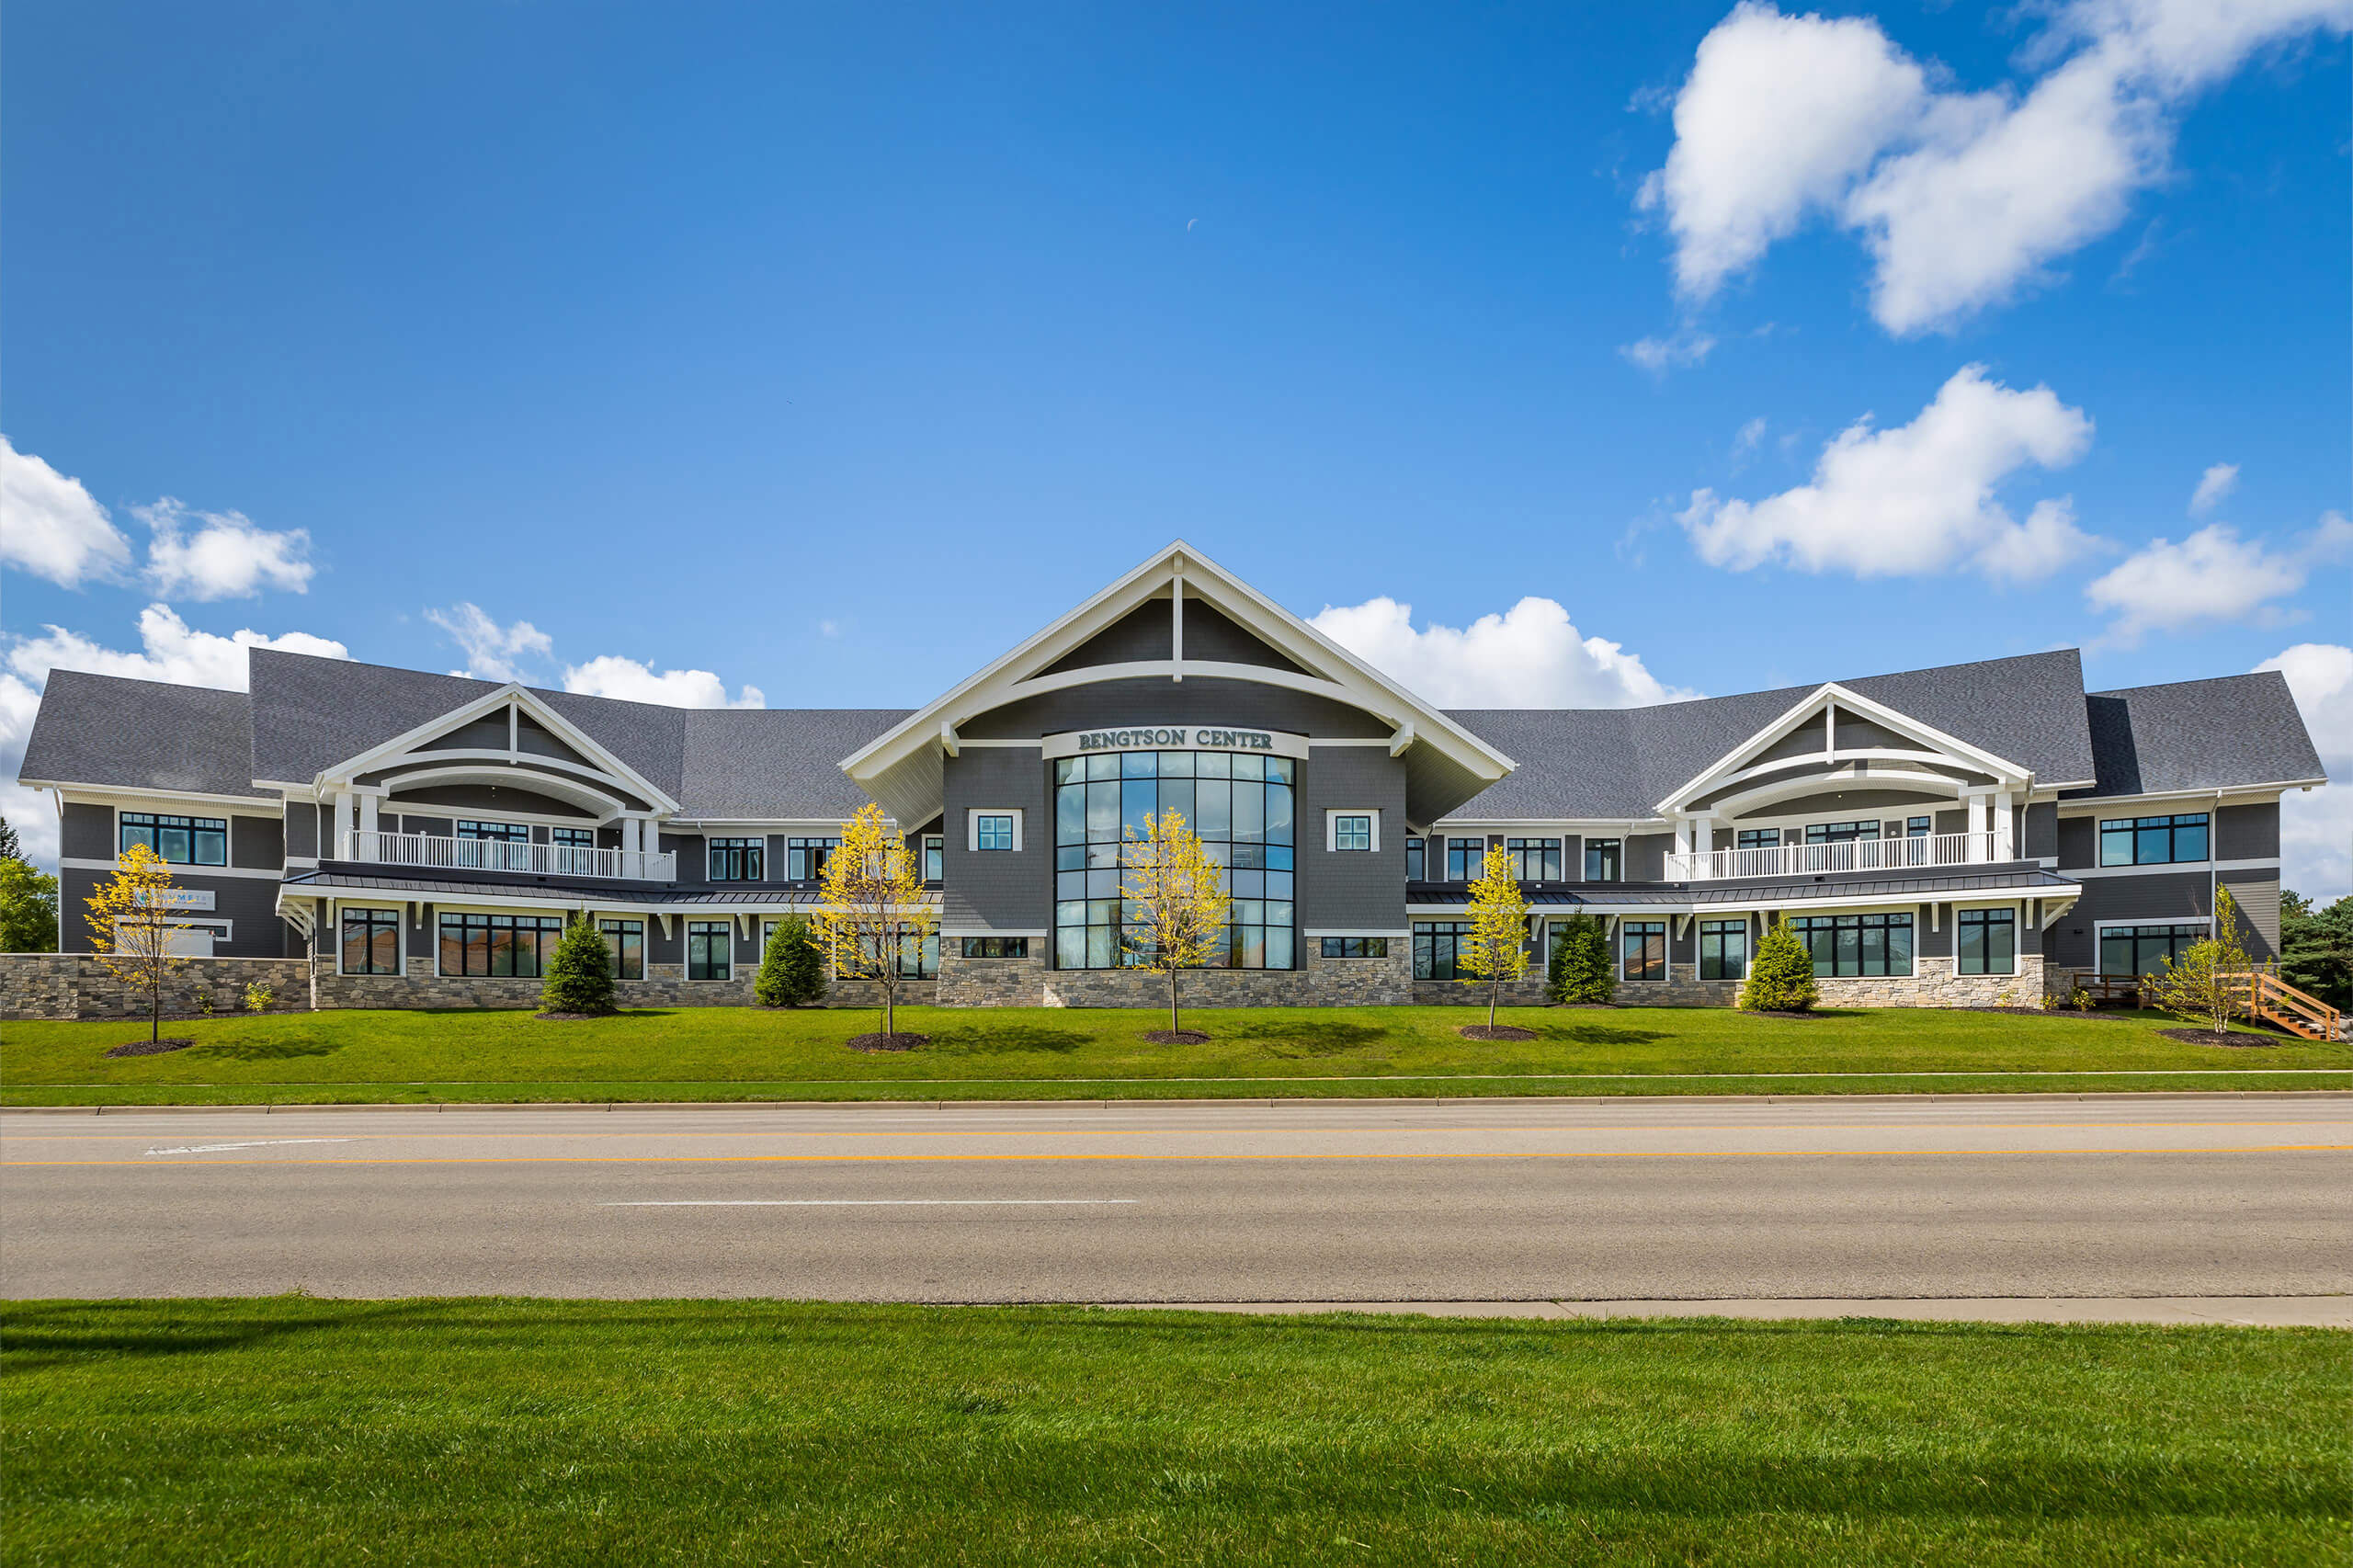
[{"x1": 842, "y1": 540, "x2": 1513, "y2": 822}]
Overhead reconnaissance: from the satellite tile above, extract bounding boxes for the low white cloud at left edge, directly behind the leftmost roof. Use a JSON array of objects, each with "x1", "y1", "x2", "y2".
[{"x1": 0, "y1": 605, "x2": 350, "y2": 867}]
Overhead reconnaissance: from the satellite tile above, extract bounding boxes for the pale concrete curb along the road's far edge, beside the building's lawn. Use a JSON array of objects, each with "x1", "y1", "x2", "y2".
[{"x1": 0, "y1": 1087, "x2": 2353, "y2": 1116}]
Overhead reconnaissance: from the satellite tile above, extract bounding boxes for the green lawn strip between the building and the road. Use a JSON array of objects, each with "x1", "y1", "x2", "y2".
[{"x1": 0, "y1": 993, "x2": 2353, "y2": 1104}]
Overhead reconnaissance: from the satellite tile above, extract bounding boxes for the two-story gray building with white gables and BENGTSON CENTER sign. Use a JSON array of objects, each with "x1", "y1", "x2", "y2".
[{"x1": 21, "y1": 544, "x2": 2325, "y2": 1006}]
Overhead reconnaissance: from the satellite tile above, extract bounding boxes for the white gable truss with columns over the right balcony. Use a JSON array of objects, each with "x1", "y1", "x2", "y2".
[{"x1": 1659, "y1": 680, "x2": 2035, "y2": 878}]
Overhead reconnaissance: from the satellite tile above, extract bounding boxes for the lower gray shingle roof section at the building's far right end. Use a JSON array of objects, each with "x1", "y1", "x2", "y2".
[{"x1": 2077, "y1": 668, "x2": 2327, "y2": 796}]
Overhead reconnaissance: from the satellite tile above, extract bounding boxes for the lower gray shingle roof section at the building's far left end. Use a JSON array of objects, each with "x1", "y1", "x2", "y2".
[{"x1": 18, "y1": 668, "x2": 270, "y2": 801}]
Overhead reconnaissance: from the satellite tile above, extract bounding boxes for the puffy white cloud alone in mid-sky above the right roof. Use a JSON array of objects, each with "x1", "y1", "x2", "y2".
[{"x1": 1677, "y1": 365, "x2": 2097, "y2": 582}]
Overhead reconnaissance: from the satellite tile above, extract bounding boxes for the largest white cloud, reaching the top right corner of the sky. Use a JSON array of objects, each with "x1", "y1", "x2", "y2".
[{"x1": 1638, "y1": 0, "x2": 2353, "y2": 335}]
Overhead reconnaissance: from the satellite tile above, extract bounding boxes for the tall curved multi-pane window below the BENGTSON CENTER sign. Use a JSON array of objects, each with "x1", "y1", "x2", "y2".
[{"x1": 1059, "y1": 751, "x2": 1299, "y2": 970}]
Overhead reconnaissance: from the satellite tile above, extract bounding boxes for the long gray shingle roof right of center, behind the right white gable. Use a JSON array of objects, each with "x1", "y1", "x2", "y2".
[{"x1": 1449, "y1": 647, "x2": 2092, "y2": 822}]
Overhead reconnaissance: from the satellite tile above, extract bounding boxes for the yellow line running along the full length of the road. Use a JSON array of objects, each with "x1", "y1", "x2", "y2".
[{"x1": 0, "y1": 1144, "x2": 2353, "y2": 1170}]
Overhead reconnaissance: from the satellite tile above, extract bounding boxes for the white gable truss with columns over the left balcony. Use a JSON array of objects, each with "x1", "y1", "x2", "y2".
[{"x1": 311, "y1": 680, "x2": 680, "y2": 857}]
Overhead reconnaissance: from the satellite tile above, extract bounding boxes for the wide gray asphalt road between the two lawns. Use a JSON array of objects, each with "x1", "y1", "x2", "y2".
[{"x1": 0, "y1": 1097, "x2": 2353, "y2": 1302}]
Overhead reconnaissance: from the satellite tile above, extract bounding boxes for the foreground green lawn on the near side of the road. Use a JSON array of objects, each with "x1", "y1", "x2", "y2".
[{"x1": 0, "y1": 1297, "x2": 2353, "y2": 1568}]
